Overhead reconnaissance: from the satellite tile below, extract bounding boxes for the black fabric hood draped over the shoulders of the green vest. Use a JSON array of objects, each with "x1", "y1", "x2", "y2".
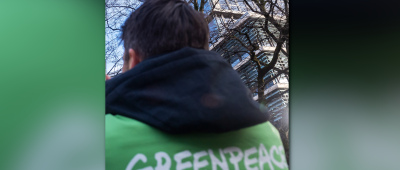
[{"x1": 106, "y1": 47, "x2": 267, "y2": 134}]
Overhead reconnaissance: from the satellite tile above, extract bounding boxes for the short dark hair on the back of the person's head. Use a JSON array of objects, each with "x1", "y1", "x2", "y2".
[{"x1": 121, "y1": 0, "x2": 209, "y2": 59}]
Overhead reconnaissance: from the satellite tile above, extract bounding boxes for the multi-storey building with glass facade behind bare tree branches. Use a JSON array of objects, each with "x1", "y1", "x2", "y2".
[{"x1": 207, "y1": 0, "x2": 289, "y2": 123}]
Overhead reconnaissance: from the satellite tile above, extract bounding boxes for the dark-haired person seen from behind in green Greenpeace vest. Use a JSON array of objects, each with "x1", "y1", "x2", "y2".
[{"x1": 105, "y1": 0, "x2": 288, "y2": 170}]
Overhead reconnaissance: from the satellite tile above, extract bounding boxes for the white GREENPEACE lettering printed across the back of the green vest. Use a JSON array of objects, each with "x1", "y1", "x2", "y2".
[{"x1": 125, "y1": 143, "x2": 288, "y2": 170}]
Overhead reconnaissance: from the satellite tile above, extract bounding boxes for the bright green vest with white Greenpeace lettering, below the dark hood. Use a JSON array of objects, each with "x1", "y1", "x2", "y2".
[{"x1": 106, "y1": 114, "x2": 288, "y2": 170}]
